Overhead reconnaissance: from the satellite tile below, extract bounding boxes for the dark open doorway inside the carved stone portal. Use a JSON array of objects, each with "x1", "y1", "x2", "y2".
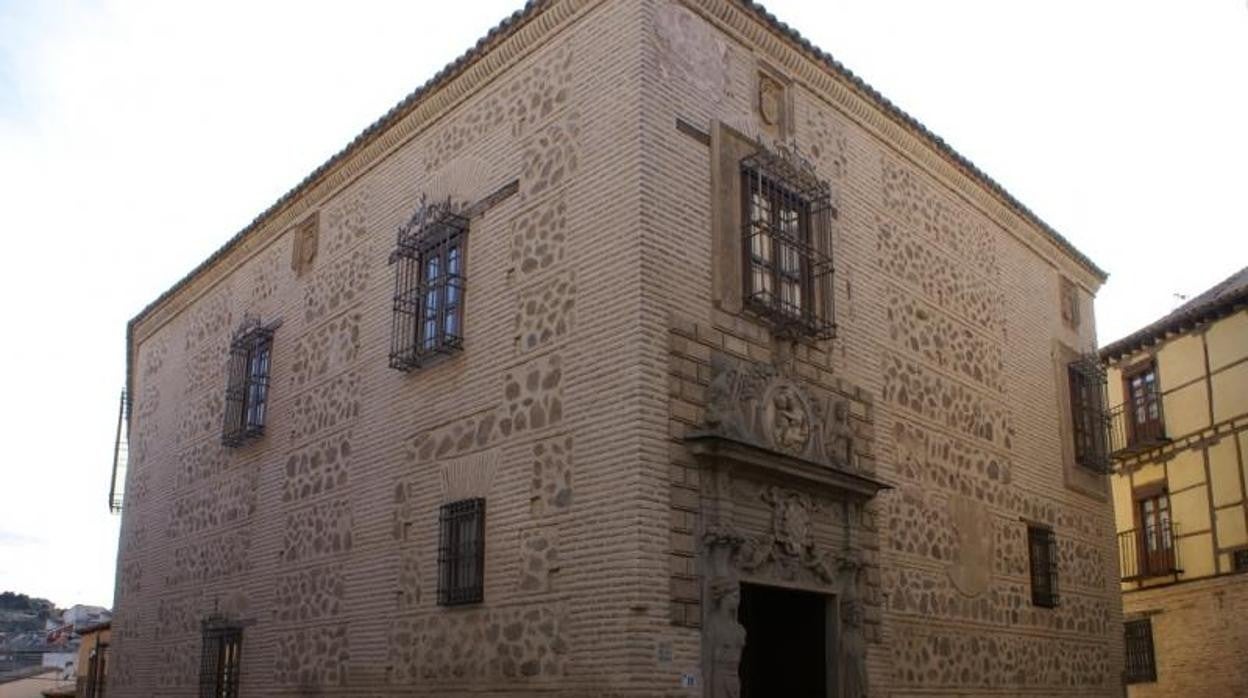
[{"x1": 738, "y1": 584, "x2": 836, "y2": 698}]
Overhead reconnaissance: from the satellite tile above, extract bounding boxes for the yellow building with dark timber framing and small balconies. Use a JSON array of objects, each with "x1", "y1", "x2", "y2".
[{"x1": 1101, "y1": 267, "x2": 1248, "y2": 697}]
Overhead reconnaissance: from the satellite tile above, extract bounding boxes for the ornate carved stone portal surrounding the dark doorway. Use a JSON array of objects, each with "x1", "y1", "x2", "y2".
[{"x1": 686, "y1": 356, "x2": 887, "y2": 698}]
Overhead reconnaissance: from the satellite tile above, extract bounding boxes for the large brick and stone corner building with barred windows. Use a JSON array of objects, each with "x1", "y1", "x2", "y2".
[{"x1": 109, "y1": 0, "x2": 1123, "y2": 697}]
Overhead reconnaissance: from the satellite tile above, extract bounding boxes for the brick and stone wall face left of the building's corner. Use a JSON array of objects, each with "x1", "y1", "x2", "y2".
[{"x1": 110, "y1": 1, "x2": 666, "y2": 696}]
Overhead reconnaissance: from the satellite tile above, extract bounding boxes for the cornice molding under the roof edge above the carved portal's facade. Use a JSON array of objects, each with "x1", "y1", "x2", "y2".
[{"x1": 679, "y1": 0, "x2": 1104, "y2": 293}]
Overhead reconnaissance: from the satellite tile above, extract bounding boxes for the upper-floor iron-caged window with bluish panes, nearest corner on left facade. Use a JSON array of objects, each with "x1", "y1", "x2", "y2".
[{"x1": 389, "y1": 201, "x2": 468, "y2": 371}]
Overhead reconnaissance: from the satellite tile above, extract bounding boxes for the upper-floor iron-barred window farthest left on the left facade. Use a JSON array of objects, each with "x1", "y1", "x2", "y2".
[{"x1": 221, "y1": 321, "x2": 273, "y2": 446}]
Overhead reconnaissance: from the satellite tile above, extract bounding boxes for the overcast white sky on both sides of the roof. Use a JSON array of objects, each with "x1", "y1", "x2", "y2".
[{"x1": 0, "y1": 0, "x2": 1248, "y2": 606}]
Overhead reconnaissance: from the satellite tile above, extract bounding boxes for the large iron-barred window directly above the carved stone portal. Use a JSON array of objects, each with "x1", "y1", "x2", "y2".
[{"x1": 741, "y1": 150, "x2": 836, "y2": 340}]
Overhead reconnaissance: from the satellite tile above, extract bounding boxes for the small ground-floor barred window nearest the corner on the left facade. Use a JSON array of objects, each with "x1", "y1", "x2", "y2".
[{"x1": 438, "y1": 498, "x2": 485, "y2": 606}]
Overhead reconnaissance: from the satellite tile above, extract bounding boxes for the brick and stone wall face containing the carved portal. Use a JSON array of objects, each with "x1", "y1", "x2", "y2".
[{"x1": 643, "y1": 1, "x2": 1122, "y2": 696}]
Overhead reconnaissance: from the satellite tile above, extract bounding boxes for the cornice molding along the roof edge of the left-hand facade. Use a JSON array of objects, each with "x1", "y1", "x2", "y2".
[{"x1": 127, "y1": 0, "x2": 603, "y2": 349}]
